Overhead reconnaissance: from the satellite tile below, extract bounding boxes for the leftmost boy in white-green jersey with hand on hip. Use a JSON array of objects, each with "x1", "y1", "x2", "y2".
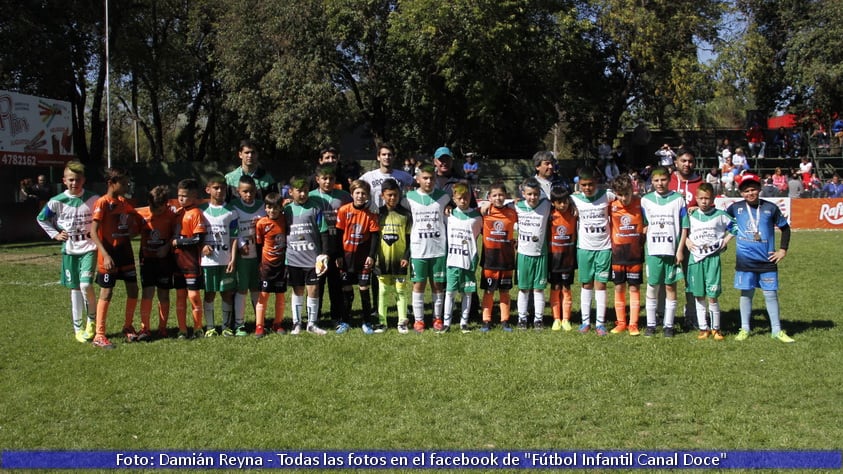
[{"x1": 37, "y1": 160, "x2": 99, "y2": 342}]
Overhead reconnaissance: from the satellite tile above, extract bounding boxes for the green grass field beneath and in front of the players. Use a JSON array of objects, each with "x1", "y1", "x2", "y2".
[{"x1": 0, "y1": 231, "x2": 843, "y2": 470}]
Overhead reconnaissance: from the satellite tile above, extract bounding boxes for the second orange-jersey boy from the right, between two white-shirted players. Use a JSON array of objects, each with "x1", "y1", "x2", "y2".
[{"x1": 547, "y1": 186, "x2": 577, "y2": 331}]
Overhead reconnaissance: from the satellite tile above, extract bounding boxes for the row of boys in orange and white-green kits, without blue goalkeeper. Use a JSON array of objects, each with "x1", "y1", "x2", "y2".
[{"x1": 39, "y1": 159, "x2": 792, "y2": 347}]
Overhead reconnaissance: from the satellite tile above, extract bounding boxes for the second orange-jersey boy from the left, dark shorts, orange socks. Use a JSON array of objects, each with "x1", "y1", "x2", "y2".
[{"x1": 138, "y1": 186, "x2": 177, "y2": 341}]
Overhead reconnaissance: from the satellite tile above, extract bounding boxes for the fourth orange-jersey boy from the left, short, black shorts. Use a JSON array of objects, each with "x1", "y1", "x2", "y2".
[{"x1": 255, "y1": 193, "x2": 287, "y2": 339}]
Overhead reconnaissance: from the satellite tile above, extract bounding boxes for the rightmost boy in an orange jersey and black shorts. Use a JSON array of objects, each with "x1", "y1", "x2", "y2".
[{"x1": 609, "y1": 174, "x2": 646, "y2": 336}]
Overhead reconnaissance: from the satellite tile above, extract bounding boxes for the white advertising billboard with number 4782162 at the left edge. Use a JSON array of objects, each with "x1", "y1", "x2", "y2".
[{"x1": 0, "y1": 90, "x2": 74, "y2": 167}]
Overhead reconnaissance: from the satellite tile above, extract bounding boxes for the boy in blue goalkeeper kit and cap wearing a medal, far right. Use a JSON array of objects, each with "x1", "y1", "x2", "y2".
[{"x1": 726, "y1": 173, "x2": 793, "y2": 342}]
